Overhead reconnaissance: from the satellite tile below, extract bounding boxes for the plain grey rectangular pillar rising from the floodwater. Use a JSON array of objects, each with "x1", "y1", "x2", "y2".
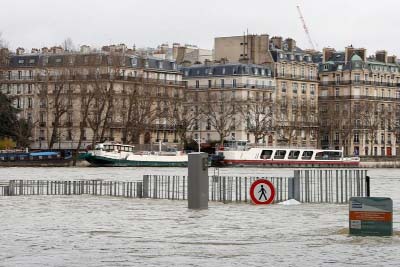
[{"x1": 188, "y1": 152, "x2": 208, "y2": 209}]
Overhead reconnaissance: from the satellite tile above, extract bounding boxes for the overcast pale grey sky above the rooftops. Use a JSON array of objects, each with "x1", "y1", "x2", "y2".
[{"x1": 0, "y1": 0, "x2": 400, "y2": 56}]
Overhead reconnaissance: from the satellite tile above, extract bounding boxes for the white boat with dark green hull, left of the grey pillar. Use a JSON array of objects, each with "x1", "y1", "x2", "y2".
[{"x1": 84, "y1": 143, "x2": 188, "y2": 167}]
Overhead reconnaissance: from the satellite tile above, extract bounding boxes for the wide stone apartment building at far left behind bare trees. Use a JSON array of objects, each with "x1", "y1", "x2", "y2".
[{"x1": 0, "y1": 45, "x2": 184, "y2": 149}]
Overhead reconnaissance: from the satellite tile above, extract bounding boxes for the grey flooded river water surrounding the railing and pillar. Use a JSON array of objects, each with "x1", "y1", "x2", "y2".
[{"x1": 0, "y1": 168, "x2": 400, "y2": 266}]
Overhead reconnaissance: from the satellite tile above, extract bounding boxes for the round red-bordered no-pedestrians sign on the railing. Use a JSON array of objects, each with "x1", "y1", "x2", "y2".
[{"x1": 250, "y1": 179, "x2": 275, "y2": 205}]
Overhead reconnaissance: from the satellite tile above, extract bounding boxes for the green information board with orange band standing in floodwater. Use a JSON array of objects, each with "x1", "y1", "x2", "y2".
[{"x1": 349, "y1": 197, "x2": 393, "y2": 236}]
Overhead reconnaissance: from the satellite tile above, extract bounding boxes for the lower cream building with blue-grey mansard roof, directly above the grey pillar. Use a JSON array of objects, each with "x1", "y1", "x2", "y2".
[{"x1": 181, "y1": 62, "x2": 276, "y2": 145}]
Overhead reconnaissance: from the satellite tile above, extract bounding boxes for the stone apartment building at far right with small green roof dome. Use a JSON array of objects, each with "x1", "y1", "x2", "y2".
[{"x1": 319, "y1": 47, "x2": 400, "y2": 156}]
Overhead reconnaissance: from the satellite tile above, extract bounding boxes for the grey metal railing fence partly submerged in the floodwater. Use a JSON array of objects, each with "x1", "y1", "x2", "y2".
[{"x1": 0, "y1": 169, "x2": 367, "y2": 203}]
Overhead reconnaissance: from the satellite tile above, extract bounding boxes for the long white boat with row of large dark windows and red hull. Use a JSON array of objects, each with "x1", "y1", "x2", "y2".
[{"x1": 212, "y1": 141, "x2": 360, "y2": 168}]
